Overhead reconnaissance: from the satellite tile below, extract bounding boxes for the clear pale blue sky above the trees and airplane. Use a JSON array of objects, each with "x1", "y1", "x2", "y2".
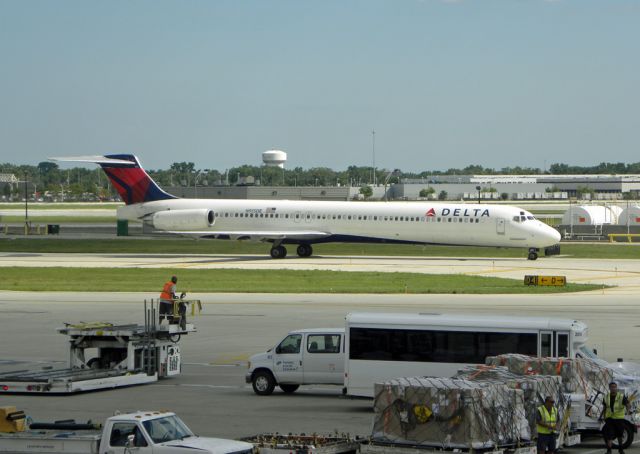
[{"x1": 0, "y1": 0, "x2": 640, "y2": 171}]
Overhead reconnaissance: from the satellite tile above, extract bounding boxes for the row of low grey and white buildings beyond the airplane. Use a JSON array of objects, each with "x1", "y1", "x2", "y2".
[{"x1": 165, "y1": 175, "x2": 640, "y2": 201}]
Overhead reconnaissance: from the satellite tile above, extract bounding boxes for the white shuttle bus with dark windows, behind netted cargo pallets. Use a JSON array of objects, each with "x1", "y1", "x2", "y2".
[{"x1": 343, "y1": 312, "x2": 595, "y2": 397}]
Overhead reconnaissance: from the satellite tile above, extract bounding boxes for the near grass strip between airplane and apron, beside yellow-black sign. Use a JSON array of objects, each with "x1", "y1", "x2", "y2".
[{"x1": 0, "y1": 268, "x2": 602, "y2": 294}]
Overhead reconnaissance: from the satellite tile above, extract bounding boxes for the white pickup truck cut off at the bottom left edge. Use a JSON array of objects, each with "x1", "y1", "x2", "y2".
[{"x1": 0, "y1": 411, "x2": 254, "y2": 454}]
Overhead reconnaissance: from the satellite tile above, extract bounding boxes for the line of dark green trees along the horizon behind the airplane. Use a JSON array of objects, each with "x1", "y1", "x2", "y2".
[{"x1": 0, "y1": 161, "x2": 640, "y2": 200}]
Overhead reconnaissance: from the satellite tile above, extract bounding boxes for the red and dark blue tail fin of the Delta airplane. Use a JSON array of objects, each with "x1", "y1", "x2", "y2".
[{"x1": 99, "y1": 154, "x2": 176, "y2": 205}]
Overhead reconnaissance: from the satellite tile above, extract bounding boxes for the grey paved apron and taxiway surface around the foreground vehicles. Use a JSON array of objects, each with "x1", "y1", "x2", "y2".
[{"x1": 0, "y1": 254, "x2": 640, "y2": 454}]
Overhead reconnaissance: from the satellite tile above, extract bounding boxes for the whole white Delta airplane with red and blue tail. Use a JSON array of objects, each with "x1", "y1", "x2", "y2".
[{"x1": 50, "y1": 154, "x2": 560, "y2": 260}]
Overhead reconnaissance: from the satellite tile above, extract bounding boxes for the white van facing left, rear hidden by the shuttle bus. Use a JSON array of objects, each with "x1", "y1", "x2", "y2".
[{"x1": 245, "y1": 328, "x2": 344, "y2": 396}]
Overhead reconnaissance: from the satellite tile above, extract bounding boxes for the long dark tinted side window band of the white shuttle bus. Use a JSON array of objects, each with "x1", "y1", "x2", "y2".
[{"x1": 349, "y1": 328, "x2": 538, "y2": 364}]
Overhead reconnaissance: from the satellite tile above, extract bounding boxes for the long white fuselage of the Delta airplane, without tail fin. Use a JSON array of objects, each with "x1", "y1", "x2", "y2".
[{"x1": 118, "y1": 199, "x2": 560, "y2": 248}]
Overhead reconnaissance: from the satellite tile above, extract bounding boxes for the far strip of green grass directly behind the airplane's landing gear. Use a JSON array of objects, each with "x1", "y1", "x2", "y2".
[{"x1": 0, "y1": 238, "x2": 640, "y2": 260}]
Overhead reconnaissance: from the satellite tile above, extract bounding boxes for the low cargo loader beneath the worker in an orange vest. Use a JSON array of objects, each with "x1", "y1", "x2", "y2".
[{"x1": 0, "y1": 300, "x2": 202, "y2": 395}]
